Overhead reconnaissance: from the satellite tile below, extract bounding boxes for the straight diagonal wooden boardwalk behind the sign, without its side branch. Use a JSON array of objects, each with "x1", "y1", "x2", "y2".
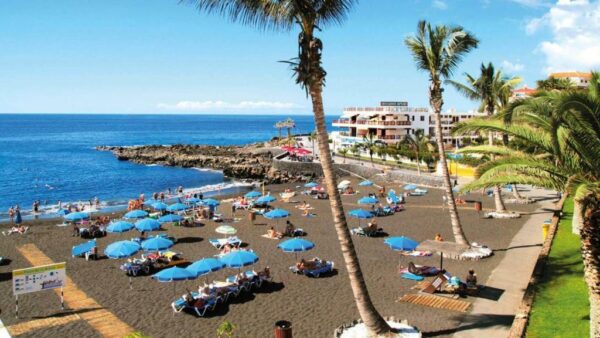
[{"x1": 17, "y1": 244, "x2": 134, "y2": 338}]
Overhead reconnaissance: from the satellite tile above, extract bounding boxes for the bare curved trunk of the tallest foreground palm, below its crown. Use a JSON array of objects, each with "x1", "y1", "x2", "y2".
[{"x1": 310, "y1": 84, "x2": 391, "y2": 334}]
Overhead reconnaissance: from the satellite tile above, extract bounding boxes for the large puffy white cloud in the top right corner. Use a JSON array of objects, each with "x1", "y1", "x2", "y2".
[{"x1": 526, "y1": 0, "x2": 600, "y2": 72}]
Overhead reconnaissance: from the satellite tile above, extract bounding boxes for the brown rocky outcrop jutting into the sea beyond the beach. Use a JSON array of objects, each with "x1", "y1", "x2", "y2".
[{"x1": 96, "y1": 143, "x2": 312, "y2": 184}]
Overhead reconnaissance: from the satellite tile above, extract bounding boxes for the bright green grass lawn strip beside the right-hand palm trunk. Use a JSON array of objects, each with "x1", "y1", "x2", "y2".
[{"x1": 526, "y1": 199, "x2": 590, "y2": 338}]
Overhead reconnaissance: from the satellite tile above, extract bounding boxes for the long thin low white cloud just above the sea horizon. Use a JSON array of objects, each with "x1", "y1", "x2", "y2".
[{"x1": 157, "y1": 101, "x2": 301, "y2": 111}]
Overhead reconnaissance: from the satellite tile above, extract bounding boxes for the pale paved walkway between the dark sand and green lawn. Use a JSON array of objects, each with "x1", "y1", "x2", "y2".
[{"x1": 454, "y1": 189, "x2": 556, "y2": 338}]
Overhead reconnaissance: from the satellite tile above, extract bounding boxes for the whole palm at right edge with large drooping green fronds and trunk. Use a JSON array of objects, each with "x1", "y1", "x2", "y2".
[{"x1": 457, "y1": 73, "x2": 600, "y2": 337}]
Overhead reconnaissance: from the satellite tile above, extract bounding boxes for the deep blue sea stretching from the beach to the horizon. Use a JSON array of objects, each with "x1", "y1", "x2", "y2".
[{"x1": 0, "y1": 114, "x2": 333, "y2": 219}]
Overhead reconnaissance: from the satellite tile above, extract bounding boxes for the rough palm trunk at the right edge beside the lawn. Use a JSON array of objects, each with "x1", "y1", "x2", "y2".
[{"x1": 573, "y1": 210, "x2": 600, "y2": 337}]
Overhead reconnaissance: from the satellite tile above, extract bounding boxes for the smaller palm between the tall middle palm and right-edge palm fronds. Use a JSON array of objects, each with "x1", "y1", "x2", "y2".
[{"x1": 446, "y1": 62, "x2": 521, "y2": 213}]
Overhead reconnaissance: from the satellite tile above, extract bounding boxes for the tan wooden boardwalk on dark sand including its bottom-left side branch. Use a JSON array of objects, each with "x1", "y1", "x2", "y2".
[{"x1": 14, "y1": 244, "x2": 134, "y2": 338}]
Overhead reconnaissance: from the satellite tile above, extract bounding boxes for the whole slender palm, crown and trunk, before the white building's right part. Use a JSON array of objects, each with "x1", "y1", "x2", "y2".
[{"x1": 404, "y1": 21, "x2": 479, "y2": 245}]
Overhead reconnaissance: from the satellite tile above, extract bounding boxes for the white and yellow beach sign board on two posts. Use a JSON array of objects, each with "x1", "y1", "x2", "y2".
[{"x1": 12, "y1": 262, "x2": 67, "y2": 318}]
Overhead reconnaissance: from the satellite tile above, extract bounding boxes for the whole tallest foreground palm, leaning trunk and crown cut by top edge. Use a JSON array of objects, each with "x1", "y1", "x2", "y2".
[{"x1": 194, "y1": 0, "x2": 391, "y2": 334}]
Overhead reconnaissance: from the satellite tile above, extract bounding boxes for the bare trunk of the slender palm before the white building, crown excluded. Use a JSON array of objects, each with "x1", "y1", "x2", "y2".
[{"x1": 429, "y1": 84, "x2": 469, "y2": 245}]
